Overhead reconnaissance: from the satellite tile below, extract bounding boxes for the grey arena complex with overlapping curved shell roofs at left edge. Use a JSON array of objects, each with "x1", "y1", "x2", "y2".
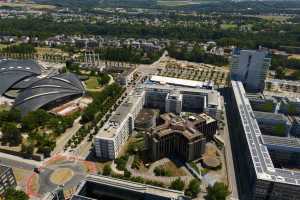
[{"x1": 0, "y1": 60, "x2": 85, "y2": 115}]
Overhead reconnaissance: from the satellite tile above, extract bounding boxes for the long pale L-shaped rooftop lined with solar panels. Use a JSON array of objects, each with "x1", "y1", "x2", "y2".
[{"x1": 231, "y1": 81, "x2": 300, "y2": 186}]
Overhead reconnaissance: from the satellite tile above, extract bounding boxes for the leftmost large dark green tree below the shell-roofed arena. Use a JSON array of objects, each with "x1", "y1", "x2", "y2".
[{"x1": 1, "y1": 122, "x2": 22, "y2": 145}]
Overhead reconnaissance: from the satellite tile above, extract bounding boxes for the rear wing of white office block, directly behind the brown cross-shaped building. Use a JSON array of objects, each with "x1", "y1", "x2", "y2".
[{"x1": 143, "y1": 84, "x2": 222, "y2": 119}]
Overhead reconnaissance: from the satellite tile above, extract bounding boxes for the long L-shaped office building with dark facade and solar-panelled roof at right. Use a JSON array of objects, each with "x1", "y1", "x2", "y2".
[{"x1": 228, "y1": 80, "x2": 300, "y2": 200}]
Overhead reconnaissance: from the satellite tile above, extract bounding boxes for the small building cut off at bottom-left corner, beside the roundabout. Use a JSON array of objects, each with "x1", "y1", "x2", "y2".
[{"x1": 0, "y1": 165, "x2": 17, "y2": 197}]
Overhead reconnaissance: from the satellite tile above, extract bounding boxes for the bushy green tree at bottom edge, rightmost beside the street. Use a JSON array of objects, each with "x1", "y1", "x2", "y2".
[{"x1": 205, "y1": 182, "x2": 230, "y2": 200}]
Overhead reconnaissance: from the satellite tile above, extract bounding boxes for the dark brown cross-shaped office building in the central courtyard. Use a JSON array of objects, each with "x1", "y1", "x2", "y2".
[{"x1": 145, "y1": 113, "x2": 217, "y2": 161}]
